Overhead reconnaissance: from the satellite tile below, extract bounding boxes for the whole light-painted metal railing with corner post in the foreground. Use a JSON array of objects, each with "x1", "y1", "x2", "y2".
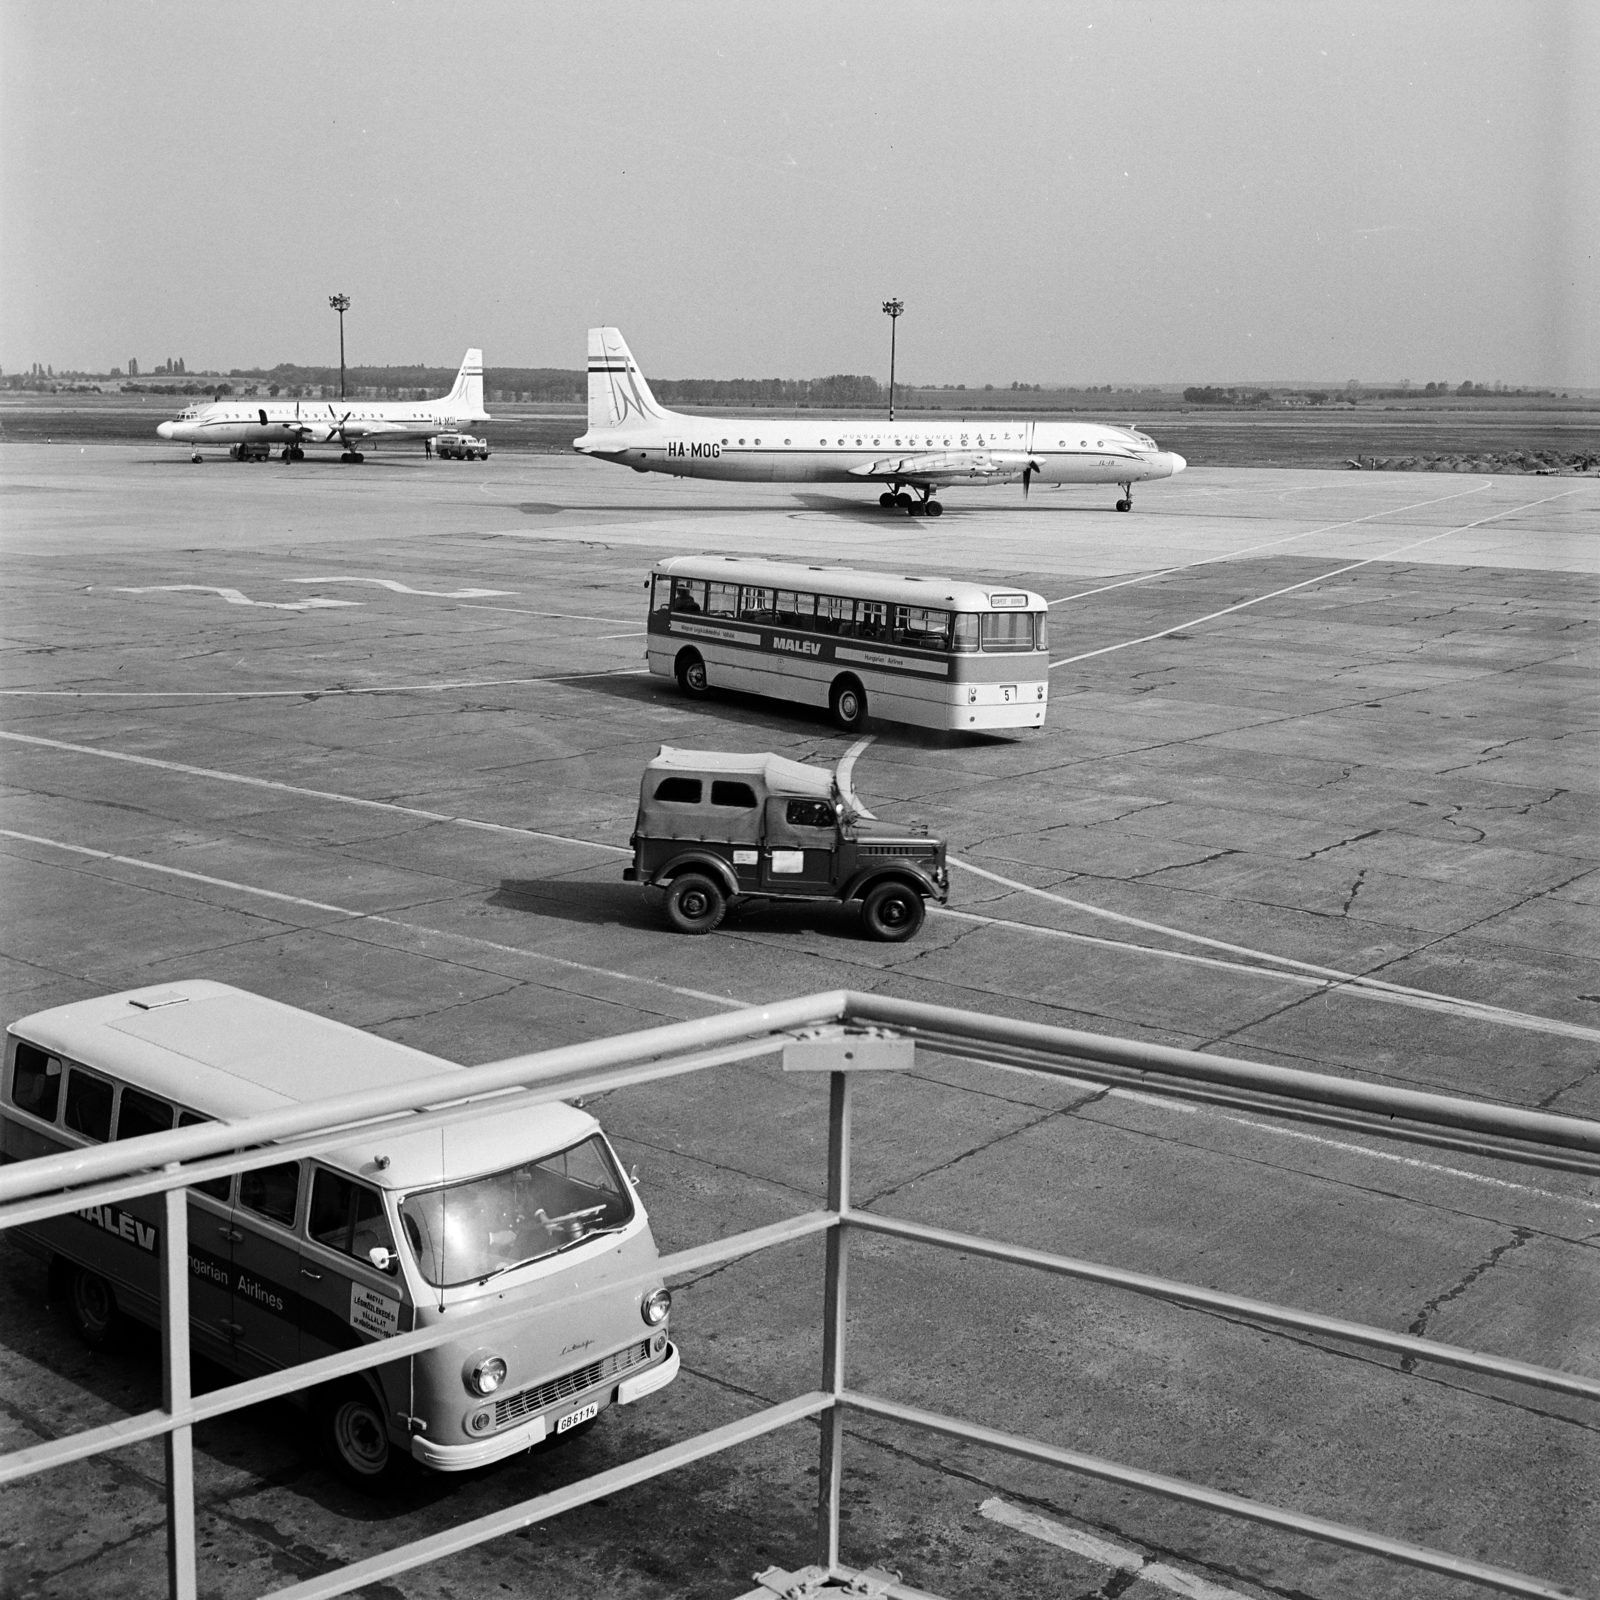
[{"x1": 0, "y1": 990, "x2": 1600, "y2": 1600}]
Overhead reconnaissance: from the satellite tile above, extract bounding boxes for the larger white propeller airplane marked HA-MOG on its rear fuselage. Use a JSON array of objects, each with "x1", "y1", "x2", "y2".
[{"x1": 573, "y1": 328, "x2": 1187, "y2": 517}]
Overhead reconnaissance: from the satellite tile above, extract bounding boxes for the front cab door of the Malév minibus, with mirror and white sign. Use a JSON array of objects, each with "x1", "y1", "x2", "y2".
[{"x1": 299, "y1": 1165, "x2": 411, "y2": 1362}]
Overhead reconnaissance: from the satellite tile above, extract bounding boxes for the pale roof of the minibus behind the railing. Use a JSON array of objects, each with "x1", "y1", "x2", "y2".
[{"x1": 8, "y1": 979, "x2": 598, "y2": 1189}]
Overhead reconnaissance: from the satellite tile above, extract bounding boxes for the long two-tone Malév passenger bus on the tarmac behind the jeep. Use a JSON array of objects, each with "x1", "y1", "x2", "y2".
[{"x1": 646, "y1": 555, "x2": 1050, "y2": 731}]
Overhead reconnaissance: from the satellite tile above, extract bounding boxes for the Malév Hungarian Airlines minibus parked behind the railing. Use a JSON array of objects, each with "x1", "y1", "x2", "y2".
[{"x1": 0, "y1": 982, "x2": 678, "y2": 1485}]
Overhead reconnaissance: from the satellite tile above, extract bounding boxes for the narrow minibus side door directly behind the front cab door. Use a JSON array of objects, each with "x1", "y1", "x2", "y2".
[{"x1": 229, "y1": 1162, "x2": 301, "y2": 1371}]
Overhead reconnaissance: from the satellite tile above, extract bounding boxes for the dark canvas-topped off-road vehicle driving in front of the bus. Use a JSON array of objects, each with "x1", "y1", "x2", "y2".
[{"x1": 622, "y1": 746, "x2": 949, "y2": 941}]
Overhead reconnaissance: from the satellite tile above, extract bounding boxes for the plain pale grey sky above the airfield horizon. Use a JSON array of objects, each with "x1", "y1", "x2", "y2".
[{"x1": 0, "y1": 0, "x2": 1600, "y2": 387}]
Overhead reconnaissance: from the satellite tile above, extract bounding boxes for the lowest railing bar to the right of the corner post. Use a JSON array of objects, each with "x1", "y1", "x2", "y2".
[{"x1": 838, "y1": 1389, "x2": 1581, "y2": 1600}]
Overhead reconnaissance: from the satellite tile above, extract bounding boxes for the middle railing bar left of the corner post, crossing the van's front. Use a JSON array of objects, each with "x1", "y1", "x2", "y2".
[{"x1": 0, "y1": 1211, "x2": 838, "y2": 1485}]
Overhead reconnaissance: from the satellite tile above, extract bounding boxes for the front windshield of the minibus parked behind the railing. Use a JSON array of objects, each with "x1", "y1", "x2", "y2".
[{"x1": 400, "y1": 1134, "x2": 634, "y2": 1288}]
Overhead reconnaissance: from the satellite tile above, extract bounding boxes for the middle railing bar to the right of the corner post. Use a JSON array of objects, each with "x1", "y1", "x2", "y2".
[{"x1": 843, "y1": 1211, "x2": 1600, "y2": 1400}]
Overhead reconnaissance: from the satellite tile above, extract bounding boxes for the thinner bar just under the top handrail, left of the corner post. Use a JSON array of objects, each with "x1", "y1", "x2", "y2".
[{"x1": 0, "y1": 1034, "x2": 794, "y2": 1229}]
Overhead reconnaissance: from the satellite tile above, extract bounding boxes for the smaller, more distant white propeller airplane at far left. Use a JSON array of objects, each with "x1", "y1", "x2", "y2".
[{"x1": 155, "y1": 350, "x2": 491, "y2": 461}]
